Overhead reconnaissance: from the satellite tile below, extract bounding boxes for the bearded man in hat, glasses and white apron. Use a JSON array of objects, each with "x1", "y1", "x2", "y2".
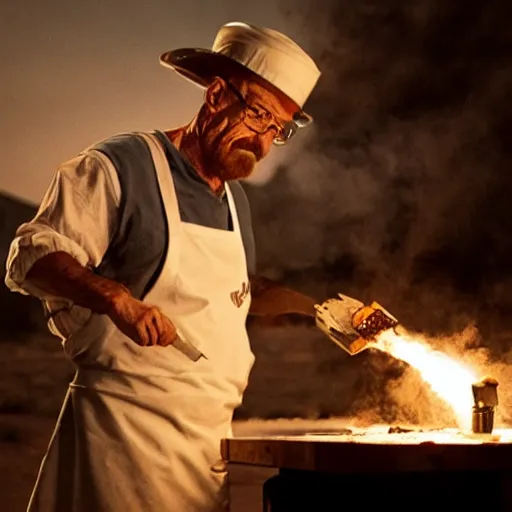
[{"x1": 6, "y1": 23, "x2": 319, "y2": 512}]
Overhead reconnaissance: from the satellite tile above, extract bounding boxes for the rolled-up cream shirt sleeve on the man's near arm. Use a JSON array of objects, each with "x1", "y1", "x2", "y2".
[{"x1": 5, "y1": 150, "x2": 121, "y2": 300}]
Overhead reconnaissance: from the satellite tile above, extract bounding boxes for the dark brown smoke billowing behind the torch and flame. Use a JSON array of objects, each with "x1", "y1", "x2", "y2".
[{"x1": 242, "y1": 0, "x2": 512, "y2": 423}]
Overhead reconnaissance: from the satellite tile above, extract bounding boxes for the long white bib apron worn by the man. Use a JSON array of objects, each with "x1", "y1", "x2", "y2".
[{"x1": 28, "y1": 134, "x2": 254, "y2": 512}]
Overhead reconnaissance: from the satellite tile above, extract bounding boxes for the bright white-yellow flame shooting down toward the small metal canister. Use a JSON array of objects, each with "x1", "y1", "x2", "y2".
[{"x1": 372, "y1": 329, "x2": 478, "y2": 429}]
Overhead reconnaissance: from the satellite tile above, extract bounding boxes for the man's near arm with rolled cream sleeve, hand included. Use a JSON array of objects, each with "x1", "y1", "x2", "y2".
[{"x1": 5, "y1": 152, "x2": 176, "y2": 345}]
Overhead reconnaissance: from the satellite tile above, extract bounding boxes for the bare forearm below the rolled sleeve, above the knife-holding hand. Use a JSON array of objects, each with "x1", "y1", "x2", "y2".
[{"x1": 26, "y1": 252, "x2": 129, "y2": 314}]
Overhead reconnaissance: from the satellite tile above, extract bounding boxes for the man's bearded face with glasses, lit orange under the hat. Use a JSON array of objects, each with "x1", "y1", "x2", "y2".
[{"x1": 202, "y1": 80, "x2": 298, "y2": 181}]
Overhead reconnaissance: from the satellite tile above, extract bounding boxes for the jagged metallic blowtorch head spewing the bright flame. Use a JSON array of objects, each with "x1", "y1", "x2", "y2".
[{"x1": 315, "y1": 293, "x2": 398, "y2": 355}]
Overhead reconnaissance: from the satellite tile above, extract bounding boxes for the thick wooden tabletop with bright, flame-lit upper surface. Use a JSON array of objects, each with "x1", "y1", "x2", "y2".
[{"x1": 222, "y1": 435, "x2": 512, "y2": 474}]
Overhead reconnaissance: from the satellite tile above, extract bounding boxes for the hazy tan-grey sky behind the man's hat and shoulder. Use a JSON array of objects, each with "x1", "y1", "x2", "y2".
[{"x1": 0, "y1": 0, "x2": 293, "y2": 202}]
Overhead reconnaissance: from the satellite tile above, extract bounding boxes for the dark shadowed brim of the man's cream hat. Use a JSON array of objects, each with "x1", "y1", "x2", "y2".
[{"x1": 160, "y1": 48, "x2": 311, "y2": 118}]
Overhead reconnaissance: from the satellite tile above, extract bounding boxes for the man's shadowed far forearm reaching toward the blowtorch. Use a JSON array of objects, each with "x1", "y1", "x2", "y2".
[{"x1": 249, "y1": 277, "x2": 316, "y2": 317}]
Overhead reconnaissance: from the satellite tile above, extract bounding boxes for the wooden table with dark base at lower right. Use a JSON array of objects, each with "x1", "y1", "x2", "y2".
[{"x1": 222, "y1": 435, "x2": 512, "y2": 512}]
